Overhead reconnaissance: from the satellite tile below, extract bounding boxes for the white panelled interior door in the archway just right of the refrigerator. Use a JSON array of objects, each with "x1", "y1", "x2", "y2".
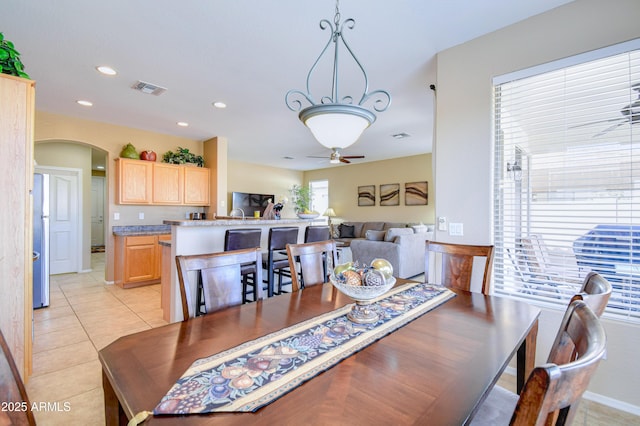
[{"x1": 37, "y1": 167, "x2": 82, "y2": 275}]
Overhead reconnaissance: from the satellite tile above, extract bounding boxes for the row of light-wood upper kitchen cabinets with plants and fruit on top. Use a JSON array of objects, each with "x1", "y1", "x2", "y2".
[{"x1": 116, "y1": 158, "x2": 211, "y2": 206}]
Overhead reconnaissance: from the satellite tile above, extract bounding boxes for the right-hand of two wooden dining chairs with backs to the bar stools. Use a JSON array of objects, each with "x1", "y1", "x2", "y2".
[{"x1": 287, "y1": 240, "x2": 338, "y2": 291}]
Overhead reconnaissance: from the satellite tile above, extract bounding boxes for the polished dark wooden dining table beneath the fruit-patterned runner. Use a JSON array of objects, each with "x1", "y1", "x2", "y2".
[{"x1": 99, "y1": 279, "x2": 540, "y2": 425}]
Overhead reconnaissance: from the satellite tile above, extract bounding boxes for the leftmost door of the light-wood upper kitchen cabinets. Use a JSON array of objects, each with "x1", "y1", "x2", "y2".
[{"x1": 116, "y1": 158, "x2": 153, "y2": 204}]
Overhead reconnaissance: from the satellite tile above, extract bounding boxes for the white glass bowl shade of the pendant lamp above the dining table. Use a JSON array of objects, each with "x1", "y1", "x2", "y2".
[{"x1": 300, "y1": 104, "x2": 376, "y2": 148}]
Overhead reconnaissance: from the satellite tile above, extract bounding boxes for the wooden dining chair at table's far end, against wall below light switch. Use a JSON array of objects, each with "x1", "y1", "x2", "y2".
[{"x1": 424, "y1": 241, "x2": 493, "y2": 294}]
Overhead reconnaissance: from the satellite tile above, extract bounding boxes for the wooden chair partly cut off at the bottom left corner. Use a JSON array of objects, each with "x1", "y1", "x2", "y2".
[{"x1": 0, "y1": 331, "x2": 36, "y2": 425}]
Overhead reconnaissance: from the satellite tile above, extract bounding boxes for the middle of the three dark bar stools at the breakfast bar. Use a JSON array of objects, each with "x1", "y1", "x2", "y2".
[{"x1": 262, "y1": 226, "x2": 298, "y2": 297}]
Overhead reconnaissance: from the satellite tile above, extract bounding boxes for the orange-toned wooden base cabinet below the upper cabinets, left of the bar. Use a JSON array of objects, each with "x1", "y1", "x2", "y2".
[{"x1": 114, "y1": 234, "x2": 171, "y2": 288}]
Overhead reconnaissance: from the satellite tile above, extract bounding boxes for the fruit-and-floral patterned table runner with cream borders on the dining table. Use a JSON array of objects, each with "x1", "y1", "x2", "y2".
[{"x1": 153, "y1": 283, "x2": 455, "y2": 415}]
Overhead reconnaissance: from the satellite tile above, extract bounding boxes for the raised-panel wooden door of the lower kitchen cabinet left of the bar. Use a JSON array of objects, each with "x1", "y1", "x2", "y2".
[{"x1": 124, "y1": 235, "x2": 158, "y2": 284}]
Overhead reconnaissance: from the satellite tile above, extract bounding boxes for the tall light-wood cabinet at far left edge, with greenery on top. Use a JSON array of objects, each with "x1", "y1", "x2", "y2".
[{"x1": 0, "y1": 74, "x2": 35, "y2": 380}]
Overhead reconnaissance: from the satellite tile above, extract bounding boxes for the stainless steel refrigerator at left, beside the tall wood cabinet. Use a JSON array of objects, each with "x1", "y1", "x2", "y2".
[{"x1": 33, "y1": 173, "x2": 49, "y2": 309}]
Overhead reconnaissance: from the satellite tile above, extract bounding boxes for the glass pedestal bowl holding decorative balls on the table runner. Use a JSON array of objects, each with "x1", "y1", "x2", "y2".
[{"x1": 329, "y1": 274, "x2": 396, "y2": 324}]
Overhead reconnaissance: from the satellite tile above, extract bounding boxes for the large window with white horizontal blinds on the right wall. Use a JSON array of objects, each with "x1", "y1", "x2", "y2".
[{"x1": 493, "y1": 40, "x2": 640, "y2": 322}]
